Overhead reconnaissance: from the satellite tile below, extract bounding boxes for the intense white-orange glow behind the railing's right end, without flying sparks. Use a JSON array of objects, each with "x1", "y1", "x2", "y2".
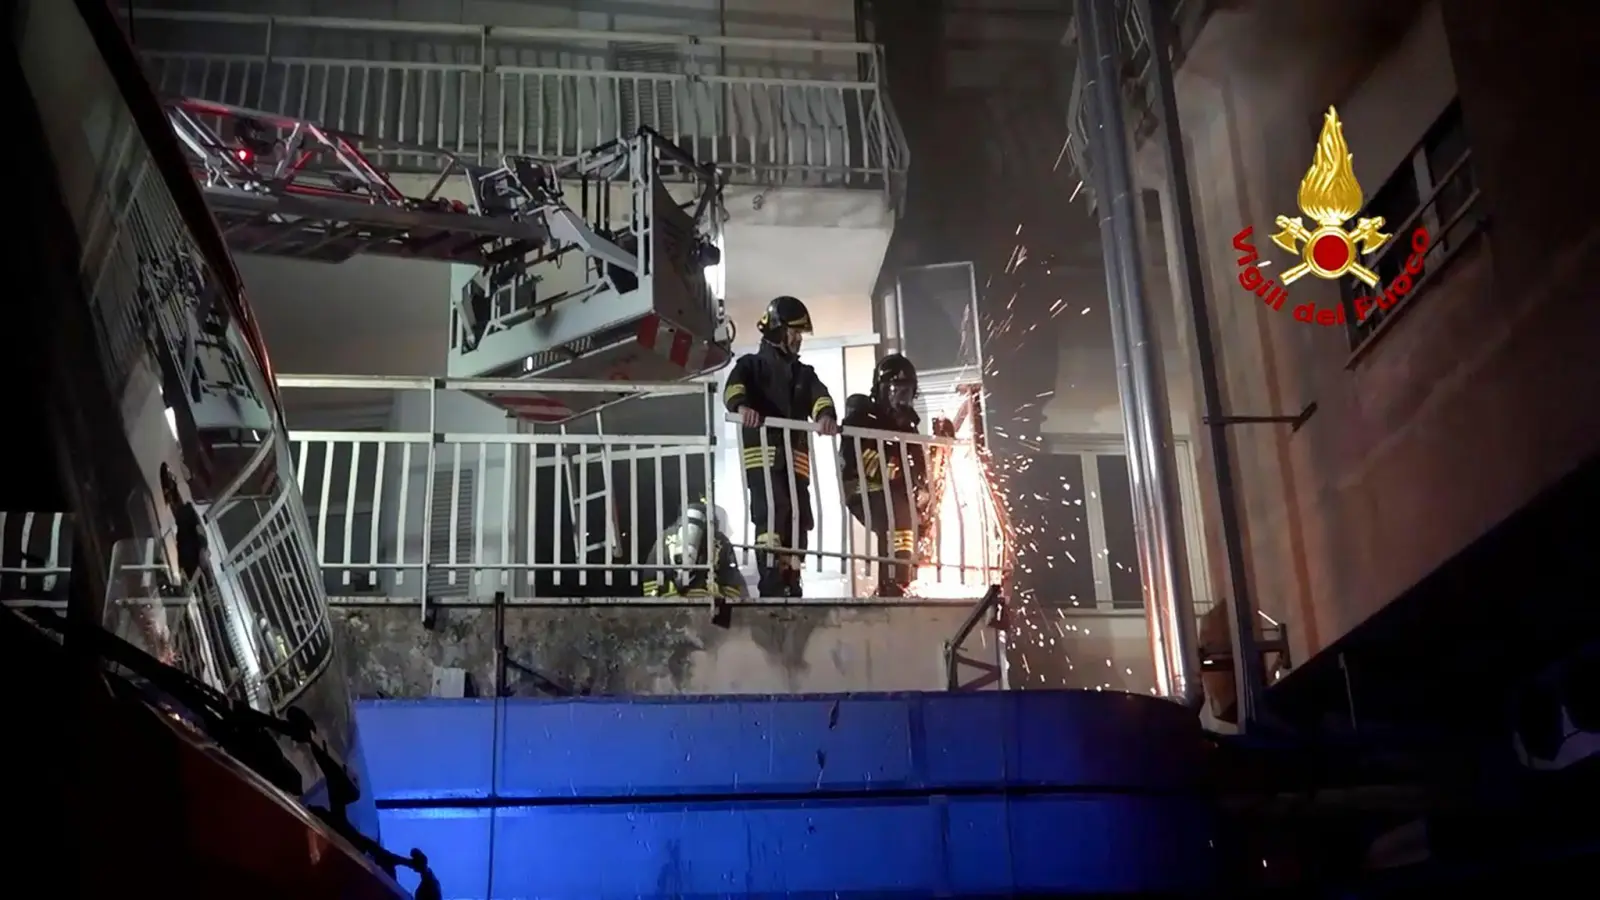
[{"x1": 910, "y1": 396, "x2": 1011, "y2": 599}]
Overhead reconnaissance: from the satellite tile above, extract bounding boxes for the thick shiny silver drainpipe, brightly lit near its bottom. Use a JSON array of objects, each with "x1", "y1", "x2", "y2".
[{"x1": 1074, "y1": 0, "x2": 1205, "y2": 708}]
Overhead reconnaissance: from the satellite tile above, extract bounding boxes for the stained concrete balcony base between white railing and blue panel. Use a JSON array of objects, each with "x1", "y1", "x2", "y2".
[{"x1": 334, "y1": 607, "x2": 994, "y2": 697}]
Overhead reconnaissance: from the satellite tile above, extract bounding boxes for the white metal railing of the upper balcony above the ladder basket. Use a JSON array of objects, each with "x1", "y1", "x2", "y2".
[{"x1": 133, "y1": 8, "x2": 907, "y2": 202}]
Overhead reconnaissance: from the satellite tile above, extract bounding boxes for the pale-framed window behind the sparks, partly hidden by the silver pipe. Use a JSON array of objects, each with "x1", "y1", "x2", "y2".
[{"x1": 1010, "y1": 436, "x2": 1210, "y2": 612}]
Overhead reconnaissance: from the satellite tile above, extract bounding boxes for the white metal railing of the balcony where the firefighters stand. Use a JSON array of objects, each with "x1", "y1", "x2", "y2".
[{"x1": 278, "y1": 368, "x2": 1006, "y2": 604}]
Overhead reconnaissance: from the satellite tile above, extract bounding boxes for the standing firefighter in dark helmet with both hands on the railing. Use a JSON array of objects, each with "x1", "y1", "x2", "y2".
[{"x1": 722, "y1": 296, "x2": 838, "y2": 597}]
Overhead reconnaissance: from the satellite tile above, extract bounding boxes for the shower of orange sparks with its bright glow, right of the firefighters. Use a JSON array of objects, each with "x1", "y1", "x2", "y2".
[{"x1": 912, "y1": 220, "x2": 1155, "y2": 693}]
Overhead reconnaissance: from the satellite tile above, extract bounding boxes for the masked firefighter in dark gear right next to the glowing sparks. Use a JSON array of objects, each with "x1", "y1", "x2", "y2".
[{"x1": 838, "y1": 354, "x2": 928, "y2": 597}]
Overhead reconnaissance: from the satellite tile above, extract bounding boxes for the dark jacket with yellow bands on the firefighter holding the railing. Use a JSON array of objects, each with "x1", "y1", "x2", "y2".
[{"x1": 722, "y1": 343, "x2": 834, "y2": 479}]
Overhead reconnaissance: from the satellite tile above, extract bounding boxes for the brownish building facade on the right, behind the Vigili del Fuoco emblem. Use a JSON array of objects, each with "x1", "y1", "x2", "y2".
[{"x1": 1100, "y1": 2, "x2": 1600, "y2": 714}]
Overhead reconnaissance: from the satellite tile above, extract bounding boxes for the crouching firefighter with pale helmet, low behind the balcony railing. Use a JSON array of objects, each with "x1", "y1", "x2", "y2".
[{"x1": 645, "y1": 498, "x2": 744, "y2": 628}]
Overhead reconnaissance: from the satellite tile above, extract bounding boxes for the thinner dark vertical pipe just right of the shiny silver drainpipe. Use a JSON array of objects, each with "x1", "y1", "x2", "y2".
[{"x1": 1134, "y1": 0, "x2": 1266, "y2": 720}]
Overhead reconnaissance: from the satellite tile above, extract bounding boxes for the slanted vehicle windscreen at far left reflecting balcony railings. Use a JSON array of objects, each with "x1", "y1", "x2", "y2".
[{"x1": 18, "y1": 12, "x2": 333, "y2": 711}]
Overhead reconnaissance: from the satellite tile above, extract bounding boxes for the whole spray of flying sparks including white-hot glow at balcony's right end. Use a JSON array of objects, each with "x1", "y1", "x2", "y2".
[{"x1": 883, "y1": 222, "x2": 1157, "y2": 695}]
